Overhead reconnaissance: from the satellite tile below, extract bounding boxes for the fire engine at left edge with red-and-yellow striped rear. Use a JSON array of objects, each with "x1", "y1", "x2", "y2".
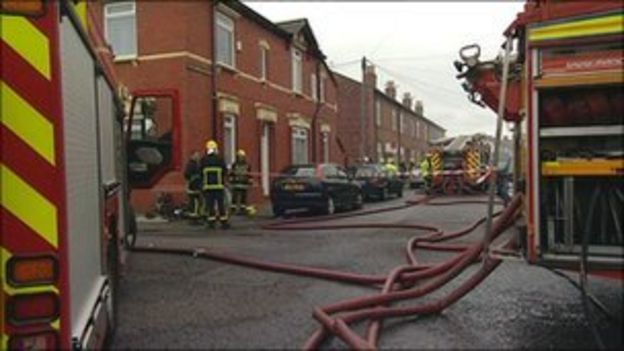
[{"x1": 0, "y1": 0, "x2": 127, "y2": 350}]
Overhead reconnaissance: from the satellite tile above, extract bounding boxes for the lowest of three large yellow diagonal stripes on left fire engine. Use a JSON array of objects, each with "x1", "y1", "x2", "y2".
[{"x1": 0, "y1": 163, "x2": 58, "y2": 248}]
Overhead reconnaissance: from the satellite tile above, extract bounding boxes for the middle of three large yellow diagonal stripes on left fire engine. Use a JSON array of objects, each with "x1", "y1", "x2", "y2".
[{"x1": 0, "y1": 80, "x2": 55, "y2": 165}]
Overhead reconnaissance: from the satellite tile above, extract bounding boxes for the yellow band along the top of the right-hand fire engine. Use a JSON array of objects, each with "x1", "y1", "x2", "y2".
[{"x1": 529, "y1": 14, "x2": 624, "y2": 41}]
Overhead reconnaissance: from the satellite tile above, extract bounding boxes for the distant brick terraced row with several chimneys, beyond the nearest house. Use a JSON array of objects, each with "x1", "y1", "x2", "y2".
[{"x1": 336, "y1": 65, "x2": 445, "y2": 164}]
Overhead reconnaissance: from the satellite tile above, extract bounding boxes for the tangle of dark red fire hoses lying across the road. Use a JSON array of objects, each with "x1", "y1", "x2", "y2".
[{"x1": 132, "y1": 194, "x2": 522, "y2": 350}]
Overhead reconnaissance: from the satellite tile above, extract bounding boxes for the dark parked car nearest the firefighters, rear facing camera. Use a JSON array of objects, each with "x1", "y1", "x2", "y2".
[{"x1": 271, "y1": 163, "x2": 364, "y2": 216}]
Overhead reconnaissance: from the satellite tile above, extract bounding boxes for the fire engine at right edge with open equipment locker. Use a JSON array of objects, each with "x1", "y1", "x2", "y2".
[{"x1": 455, "y1": 0, "x2": 624, "y2": 278}]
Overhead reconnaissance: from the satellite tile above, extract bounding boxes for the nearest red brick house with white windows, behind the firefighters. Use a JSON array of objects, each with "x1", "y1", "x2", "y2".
[{"x1": 90, "y1": 1, "x2": 336, "y2": 212}]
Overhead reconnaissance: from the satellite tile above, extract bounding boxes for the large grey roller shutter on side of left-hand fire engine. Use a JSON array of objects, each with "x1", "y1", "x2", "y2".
[{"x1": 60, "y1": 13, "x2": 104, "y2": 336}]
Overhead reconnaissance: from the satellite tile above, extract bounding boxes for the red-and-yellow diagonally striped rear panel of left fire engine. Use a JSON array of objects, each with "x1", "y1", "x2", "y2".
[{"x1": 0, "y1": 1, "x2": 69, "y2": 349}]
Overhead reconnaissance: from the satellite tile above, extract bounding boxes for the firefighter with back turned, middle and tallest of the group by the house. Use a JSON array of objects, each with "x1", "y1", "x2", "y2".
[{"x1": 201, "y1": 140, "x2": 230, "y2": 229}]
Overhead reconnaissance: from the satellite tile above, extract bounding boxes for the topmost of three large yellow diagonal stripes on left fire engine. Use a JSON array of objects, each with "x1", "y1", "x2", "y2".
[{"x1": 0, "y1": 16, "x2": 51, "y2": 80}]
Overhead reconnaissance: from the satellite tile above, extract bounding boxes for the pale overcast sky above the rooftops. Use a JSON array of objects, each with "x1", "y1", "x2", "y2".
[{"x1": 245, "y1": 1, "x2": 524, "y2": 135}]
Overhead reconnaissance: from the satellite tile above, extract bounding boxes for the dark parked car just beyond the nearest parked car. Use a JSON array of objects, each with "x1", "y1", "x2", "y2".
[{"x1": 349, "y1": 164, "x2": 405, "y2": 200}]
